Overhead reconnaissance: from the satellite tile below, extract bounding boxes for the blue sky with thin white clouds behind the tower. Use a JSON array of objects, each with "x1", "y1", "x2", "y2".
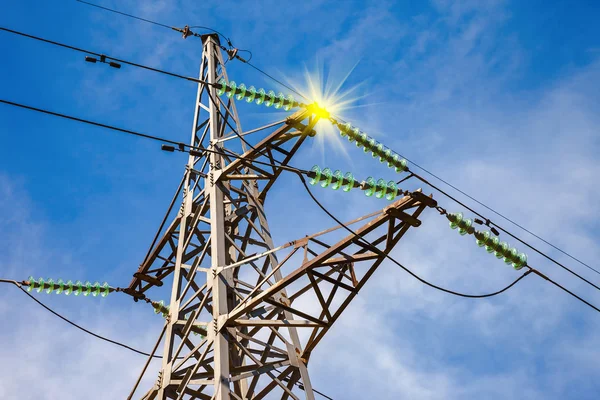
[{"x1": 0, "y1": 0, "x2": 600, "y2": 400}]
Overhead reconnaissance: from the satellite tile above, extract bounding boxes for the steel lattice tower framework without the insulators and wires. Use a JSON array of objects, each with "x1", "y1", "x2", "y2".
[{"x1": 127, "y1": 35, "x2": 431, "y2": 400}]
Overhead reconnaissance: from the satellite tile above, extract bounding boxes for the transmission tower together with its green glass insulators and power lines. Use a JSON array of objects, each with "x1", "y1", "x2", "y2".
[{"x1": 0, "y1": 7, "x2": 600, "y2": 400}]
